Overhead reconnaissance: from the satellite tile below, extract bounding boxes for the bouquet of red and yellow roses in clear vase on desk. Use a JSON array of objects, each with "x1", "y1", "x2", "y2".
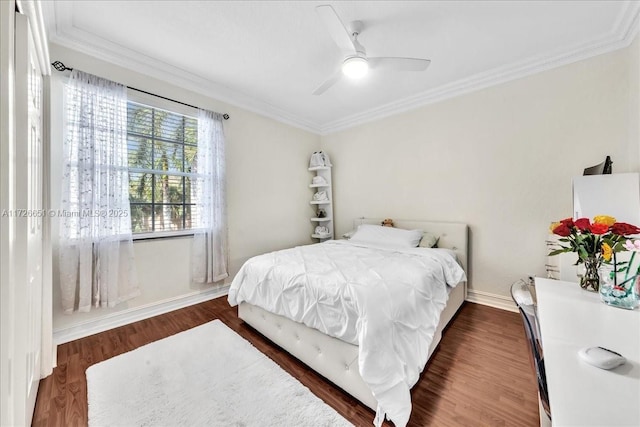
[{"x1": 549, "y1": 215, "x2": 640, "y2": 300}]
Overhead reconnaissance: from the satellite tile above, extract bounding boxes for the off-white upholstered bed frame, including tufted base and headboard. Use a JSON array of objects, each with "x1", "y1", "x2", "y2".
[{"x1": 238, "y1": 218, "x2": 469, "y2": 411}]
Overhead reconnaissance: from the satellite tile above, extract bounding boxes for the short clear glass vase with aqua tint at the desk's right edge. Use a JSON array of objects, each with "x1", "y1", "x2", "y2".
[{"x1": 599, "y1": 265, "x2": 640, "y2": 310}]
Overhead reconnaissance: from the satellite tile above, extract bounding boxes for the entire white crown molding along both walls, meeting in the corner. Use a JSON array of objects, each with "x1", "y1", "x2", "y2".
[{"x1": 43, "y1": 1, "x2": 640, "y2": 135}]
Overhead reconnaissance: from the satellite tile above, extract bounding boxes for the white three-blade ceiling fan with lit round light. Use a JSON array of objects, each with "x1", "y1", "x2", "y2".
[{"x1": 313, "y1": 5, "x2": 431, "y2": 95}]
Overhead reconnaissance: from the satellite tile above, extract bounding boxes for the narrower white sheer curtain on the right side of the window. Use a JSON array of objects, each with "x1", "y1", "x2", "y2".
[{"x1": 192, "y1": 110, "x2": 229, "y2": 283}]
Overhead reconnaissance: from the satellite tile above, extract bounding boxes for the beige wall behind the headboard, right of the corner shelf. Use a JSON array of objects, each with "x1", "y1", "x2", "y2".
[{"x1": 322, "y1": 42, "x2": 640, "y2": 296}]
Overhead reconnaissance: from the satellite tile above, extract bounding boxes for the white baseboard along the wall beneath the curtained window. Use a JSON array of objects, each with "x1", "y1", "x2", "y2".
[{"x1": 53, "y1": 285, "x2": 229, "y2": 346}]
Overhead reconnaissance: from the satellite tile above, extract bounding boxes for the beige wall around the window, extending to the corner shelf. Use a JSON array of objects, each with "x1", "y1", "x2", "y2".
[{"x1": 51, "y1": 44, "x2": 320, "y2": 330}]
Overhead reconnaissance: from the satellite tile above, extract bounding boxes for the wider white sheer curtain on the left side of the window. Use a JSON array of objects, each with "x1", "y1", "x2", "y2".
[{"x1": 59, "y1": 70, "x2": 140, "y2": 313}]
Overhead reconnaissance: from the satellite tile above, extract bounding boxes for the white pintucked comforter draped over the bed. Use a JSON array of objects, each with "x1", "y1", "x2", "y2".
[{"x1": 229, "y1": 241, "x2": 466, "y2": 427}]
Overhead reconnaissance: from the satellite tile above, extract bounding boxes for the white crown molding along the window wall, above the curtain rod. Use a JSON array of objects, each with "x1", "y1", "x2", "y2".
[{"x1": 45, "y1": 2, "x2": 320, "y2": 134}]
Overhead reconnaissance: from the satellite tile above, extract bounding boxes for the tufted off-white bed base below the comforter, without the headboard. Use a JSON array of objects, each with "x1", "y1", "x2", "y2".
[{"x1": 238, "y1": 283, "x2": 467, "y2": 411}]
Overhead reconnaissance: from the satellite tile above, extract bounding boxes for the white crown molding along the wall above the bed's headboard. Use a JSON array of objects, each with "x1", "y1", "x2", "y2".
[{"x1": 320, "y1": 1, "x2": 640, "y2": 135}]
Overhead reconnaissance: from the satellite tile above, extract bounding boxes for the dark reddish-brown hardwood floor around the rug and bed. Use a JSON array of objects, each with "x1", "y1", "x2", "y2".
[{"x1": 33, "y1": 298, "x2": 539, "y2": 426}]
